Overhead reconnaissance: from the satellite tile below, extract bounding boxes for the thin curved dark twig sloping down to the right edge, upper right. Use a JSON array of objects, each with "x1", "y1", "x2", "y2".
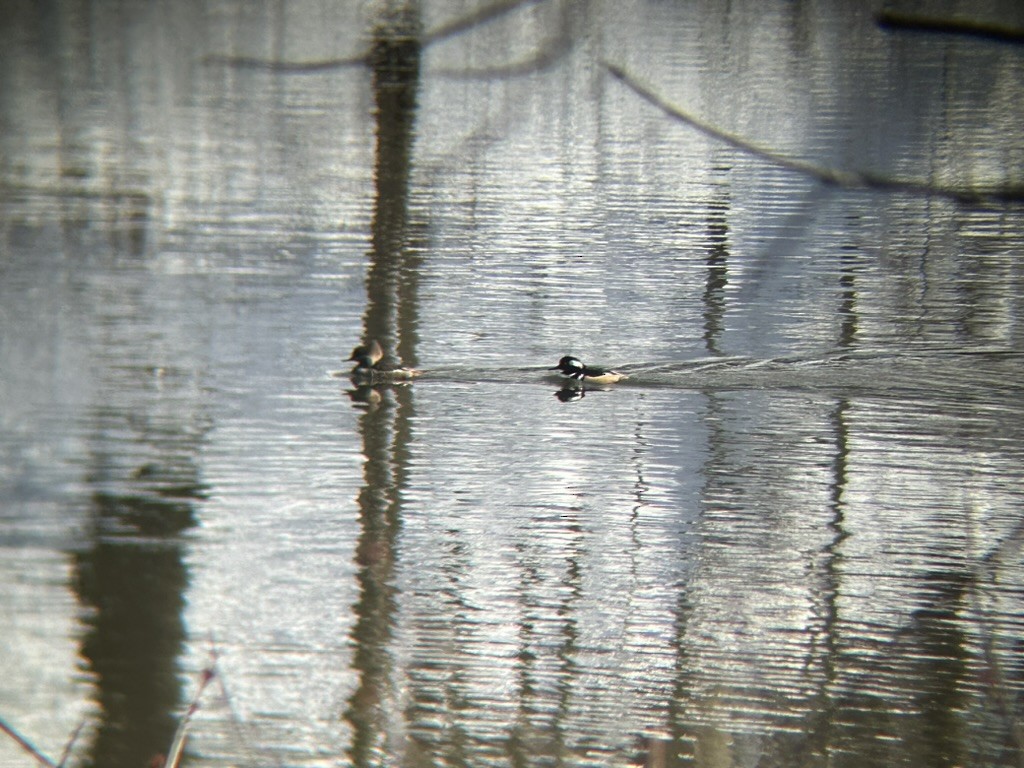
[{"x1": 604, "y1": 63, "x2": 1024, "y2": 203}]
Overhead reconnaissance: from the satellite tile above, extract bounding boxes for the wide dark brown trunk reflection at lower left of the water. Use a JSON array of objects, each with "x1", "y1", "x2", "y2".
[{"x1": 74, "y1": 408, "x2": 204, "y2": 768}]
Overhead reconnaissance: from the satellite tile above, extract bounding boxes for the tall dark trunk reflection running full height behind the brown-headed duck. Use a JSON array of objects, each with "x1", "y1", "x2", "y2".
[{"x1": 344, "y1": 3, "x2": 421, "y2": 766}]
